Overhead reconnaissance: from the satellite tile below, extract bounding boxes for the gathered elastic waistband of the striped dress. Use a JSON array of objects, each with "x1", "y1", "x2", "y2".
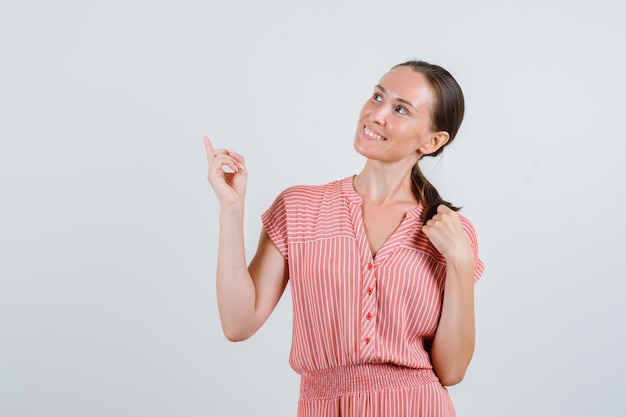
[{"x1": 300, "y1": 363, "x2": 439, "y2": 400}]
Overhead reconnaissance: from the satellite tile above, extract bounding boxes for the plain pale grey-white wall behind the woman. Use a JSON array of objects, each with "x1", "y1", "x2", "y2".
[{"x1": 0, "y1": 0, "x2": 626, "y2": 417}]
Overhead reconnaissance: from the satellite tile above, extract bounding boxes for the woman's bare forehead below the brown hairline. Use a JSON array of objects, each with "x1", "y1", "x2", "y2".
[{"x1": 380, "y1": 66, "x2": 433, "y2": 107}]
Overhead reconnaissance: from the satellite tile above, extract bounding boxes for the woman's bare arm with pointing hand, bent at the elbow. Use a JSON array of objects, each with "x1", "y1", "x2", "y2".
[{"x1": 203, "y1": 136, "x2": 287, "y2": 341}]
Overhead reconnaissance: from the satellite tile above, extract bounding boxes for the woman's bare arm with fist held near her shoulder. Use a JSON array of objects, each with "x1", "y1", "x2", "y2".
[{"x1": 422, "y1": 206, "x2": 475, "y2": 385}]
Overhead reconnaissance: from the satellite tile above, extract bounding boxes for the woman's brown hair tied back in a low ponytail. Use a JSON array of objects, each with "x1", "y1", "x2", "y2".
[{"x1": 393, "y1": 61, "x2": 465, "y2": 222}]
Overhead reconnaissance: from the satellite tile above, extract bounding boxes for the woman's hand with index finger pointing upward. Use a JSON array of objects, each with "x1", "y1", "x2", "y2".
[{"x1": 202, "y1": 135, "x2": 248, "y2": 205}]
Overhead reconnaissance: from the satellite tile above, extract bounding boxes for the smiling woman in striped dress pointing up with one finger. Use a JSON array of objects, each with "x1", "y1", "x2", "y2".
[{"x1": 204, "y1": 61, "x2": 483, "y2": 417}]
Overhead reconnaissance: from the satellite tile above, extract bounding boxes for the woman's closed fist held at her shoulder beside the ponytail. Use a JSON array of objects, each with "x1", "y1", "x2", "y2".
[{"x1": 422, "y1": 204, "x2": 474, "y2": 263}]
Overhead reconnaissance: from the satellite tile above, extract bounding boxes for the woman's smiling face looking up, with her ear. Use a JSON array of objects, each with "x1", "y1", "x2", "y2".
[{"x1": 354, "y1": 67, "x2": 447, "y2": 166}]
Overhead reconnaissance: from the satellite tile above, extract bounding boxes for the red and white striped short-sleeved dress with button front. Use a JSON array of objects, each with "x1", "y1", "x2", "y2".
[{"x1": 262, "y1": 177, "x2": 484, "y2": 417}]
